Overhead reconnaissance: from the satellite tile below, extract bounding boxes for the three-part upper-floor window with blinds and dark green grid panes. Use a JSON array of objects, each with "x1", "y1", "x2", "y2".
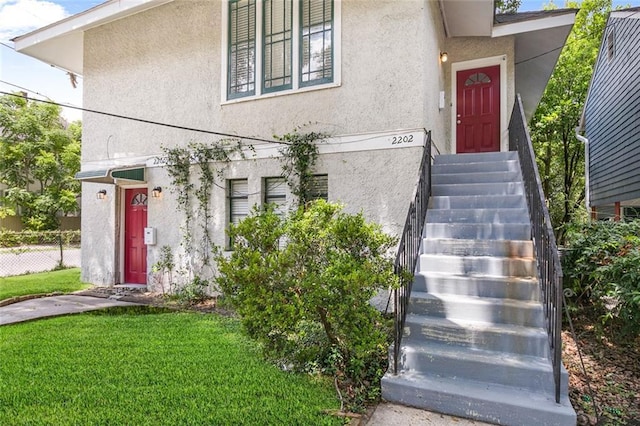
[{"x1": 226, "y1": 0, "x2": 339, "y2": 100}]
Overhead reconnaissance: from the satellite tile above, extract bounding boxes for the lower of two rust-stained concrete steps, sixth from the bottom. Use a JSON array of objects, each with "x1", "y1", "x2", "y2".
[{"x1": 418, "y1": 254, "x2": 537, "y2": 277}]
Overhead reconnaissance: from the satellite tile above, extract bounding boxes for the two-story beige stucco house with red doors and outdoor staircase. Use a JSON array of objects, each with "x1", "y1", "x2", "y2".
[{"x1": 15, "y1": 0, "x2": 576, "y2": 425}]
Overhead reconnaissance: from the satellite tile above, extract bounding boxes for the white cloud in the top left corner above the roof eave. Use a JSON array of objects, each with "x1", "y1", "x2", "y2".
[{"x1": 0, "y1": 0, "x2": 69, "y2": 42}]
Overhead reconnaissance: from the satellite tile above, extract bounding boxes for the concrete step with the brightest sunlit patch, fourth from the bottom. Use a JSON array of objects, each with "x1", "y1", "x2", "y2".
[{"x1": 409, "y1": 290, "x2": 545, "y2": 328}]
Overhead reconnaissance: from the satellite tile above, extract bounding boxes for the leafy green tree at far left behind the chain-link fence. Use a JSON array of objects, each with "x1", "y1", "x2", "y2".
[{"x1": 0, "y1": 95, "x2": 82, "y2": 230}]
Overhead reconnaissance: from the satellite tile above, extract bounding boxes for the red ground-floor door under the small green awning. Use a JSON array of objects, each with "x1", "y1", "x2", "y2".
[{"x1": 124, "y1": 188, "x2": 147, "y2": 284}]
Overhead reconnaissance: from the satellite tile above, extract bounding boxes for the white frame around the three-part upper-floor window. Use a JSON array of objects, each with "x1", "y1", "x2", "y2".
[{"x1": 220, "y1": 0, "x2": 342, "y2": 105}]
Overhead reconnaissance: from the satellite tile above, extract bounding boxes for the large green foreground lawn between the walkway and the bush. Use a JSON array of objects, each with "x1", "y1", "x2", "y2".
[{"x1": 0, "y1": 307, "x2": 342, "y2": 425}]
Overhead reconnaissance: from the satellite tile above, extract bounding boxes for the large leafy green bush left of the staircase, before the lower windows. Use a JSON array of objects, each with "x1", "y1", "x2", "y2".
[{"x1": 215, "y1": 201, "x2": 397, "y2": 409}]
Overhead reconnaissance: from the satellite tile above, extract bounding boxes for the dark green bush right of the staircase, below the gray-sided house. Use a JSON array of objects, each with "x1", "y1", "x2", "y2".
[{"x1": 563, "y1": 220, "x2": 640, "y2": 335}]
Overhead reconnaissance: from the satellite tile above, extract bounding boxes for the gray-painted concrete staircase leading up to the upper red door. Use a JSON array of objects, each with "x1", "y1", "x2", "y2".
[{"x1": 382, "y1": 152, "x2": 576, "y2": 426}]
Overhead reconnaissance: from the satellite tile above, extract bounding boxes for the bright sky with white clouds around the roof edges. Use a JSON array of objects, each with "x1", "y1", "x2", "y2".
[{"x1": 0, "y1": 0, "x2": 640, "y2": 121}]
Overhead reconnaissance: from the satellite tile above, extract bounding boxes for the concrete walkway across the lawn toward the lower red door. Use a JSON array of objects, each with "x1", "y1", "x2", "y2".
[{"x1": 0, "y1": 294, "x2": 140, "y2": 326}]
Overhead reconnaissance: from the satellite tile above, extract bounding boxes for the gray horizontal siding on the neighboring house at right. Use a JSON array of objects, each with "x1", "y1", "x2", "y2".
[{"x1": 585, "y1": 15, "x2": 640, "y2": 206}]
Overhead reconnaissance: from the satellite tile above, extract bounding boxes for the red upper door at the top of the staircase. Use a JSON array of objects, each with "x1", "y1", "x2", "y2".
[{"x1": 456, "y1": 65, "x2": 500, "y2": 154}]
